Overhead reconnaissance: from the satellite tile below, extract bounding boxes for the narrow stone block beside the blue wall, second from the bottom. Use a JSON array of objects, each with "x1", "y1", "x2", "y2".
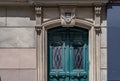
[{"x1": 101, "y1": 49, "x2": 107, "y2": 68}]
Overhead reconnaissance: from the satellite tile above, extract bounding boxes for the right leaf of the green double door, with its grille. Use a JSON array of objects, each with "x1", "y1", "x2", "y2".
[{"x1": 70, "y1": 29, "x2": 88, "y2": 81}]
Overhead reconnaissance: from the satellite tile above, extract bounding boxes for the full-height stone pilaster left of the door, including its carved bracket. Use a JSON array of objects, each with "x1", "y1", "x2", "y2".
[{"x1": 35, "y1": 6, "x2": 43, "y2": 81}]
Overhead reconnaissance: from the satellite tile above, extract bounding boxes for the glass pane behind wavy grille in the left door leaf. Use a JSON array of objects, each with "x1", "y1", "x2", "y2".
[{"x1": 52, "y1": 46, "x2": 62, "y2": 69}]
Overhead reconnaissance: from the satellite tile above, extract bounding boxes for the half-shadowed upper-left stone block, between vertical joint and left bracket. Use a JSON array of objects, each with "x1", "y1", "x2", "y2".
[{"x1": 7, "y1": 7, "x2": 36, "y2": 26}]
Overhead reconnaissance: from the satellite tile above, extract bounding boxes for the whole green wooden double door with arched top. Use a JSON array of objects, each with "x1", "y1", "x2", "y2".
[{"x1": 48, "y1": 27, "x2": 89, "y2": 81}]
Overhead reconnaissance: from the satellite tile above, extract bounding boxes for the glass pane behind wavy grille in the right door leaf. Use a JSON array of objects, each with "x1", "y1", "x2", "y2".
[{"x1": 73, "y1": 45, "x2": 83, "y2": 69}]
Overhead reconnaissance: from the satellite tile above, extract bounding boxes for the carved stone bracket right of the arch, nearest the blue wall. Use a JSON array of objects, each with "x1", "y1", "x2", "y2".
[{"x1": 95, "y1": 5, "x2": 101, "y2": 34}]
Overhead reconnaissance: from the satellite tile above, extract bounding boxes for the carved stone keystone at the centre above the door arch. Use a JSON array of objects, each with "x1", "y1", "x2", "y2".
[{"x1": 60, "y1": 6, "x2": 75, "y2": 27}]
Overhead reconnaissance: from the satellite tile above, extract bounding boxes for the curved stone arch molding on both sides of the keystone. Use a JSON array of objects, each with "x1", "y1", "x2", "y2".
[{"x1": 42, "y1": 19, "x2": 94, "y2": 29}]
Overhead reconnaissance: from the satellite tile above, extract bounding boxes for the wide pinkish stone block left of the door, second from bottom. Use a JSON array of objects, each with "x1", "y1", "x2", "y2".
[{"x1": 0, "y1": 49, "x2": 36, "y2": 69}]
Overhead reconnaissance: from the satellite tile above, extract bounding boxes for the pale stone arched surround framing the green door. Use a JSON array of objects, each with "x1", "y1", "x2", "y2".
[{"x1": 36, "y1": 6, "x2": 107, "y2": 81}]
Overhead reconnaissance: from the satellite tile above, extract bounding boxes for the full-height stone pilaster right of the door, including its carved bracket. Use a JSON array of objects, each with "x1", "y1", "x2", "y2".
[{"x1": 94, "y1": 5, "x2": 101, "y2": 81}]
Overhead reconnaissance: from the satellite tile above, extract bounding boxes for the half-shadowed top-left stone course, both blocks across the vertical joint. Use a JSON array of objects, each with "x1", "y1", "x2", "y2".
[{"x1": 0, "y1": 6, "x2": 36, "y2": 26}]
